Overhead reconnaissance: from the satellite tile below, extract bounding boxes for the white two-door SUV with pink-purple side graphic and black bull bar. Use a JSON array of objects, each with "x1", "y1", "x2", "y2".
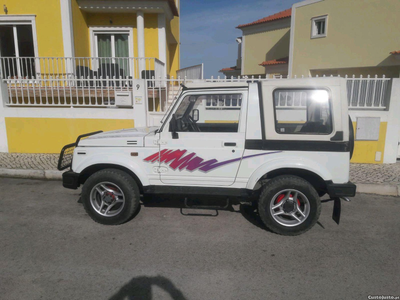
[{"x1": 59, "y1": 78, "x2": 356, "y2": 235}]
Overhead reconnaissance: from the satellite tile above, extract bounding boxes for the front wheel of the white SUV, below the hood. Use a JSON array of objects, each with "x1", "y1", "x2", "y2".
[{"x1": 82, "y1": 169, "x2": 140, "y2": 225}]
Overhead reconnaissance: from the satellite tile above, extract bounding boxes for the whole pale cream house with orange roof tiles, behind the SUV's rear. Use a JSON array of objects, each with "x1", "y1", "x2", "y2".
[{"x1": 225, "y1": 0, "x2": 400, "y2": 78}]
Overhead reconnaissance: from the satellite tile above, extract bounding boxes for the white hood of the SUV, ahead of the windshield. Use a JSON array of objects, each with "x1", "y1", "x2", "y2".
[{"x1": 78, "y1": 127, "x2": 159, "y2": 147}]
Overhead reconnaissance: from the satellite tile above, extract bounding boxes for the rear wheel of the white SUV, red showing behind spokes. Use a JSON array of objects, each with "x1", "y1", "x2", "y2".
[{"x1": 258, "y1": 175, "x2": 321, "y2": 236}]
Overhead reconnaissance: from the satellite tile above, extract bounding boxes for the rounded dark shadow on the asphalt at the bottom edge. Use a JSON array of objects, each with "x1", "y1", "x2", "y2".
[{"x1": 109, "y1": 276, "x2": 186, "y2": 300}]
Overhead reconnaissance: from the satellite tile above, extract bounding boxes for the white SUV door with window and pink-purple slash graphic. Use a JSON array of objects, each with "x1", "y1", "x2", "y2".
[{"x1": 148, "y1": 90, "x2": 247, "y2": 186}]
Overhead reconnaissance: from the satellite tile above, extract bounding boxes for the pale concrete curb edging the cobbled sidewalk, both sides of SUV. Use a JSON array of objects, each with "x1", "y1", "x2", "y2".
[{"x1": 0, "y1": 168, "x2": 400, "y2": 196}]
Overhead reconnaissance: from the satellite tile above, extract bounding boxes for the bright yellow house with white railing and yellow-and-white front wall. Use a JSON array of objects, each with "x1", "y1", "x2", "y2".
[{"x1": 0, "y1": 0, "x2": 180, "y2": 153}]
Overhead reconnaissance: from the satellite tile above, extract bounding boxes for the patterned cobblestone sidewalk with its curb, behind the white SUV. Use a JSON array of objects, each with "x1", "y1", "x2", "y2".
[{"x1": 0, "y1": 153, "x2": 400, "y2": 196}]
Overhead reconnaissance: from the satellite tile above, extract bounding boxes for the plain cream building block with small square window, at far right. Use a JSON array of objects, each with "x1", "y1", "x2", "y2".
[{"x1": 289, "y1": 0, "x2": 400, "y2": 78}]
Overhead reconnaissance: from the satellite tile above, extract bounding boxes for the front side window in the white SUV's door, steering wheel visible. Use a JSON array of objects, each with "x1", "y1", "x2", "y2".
[{"x1": 171, "y1": 94, "x2": 242, "y2": 132}]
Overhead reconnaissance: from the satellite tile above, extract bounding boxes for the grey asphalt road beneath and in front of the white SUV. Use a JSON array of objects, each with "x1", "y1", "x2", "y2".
[{"x1": 0, "y1": 178, "x2": 400, "y2": 300}]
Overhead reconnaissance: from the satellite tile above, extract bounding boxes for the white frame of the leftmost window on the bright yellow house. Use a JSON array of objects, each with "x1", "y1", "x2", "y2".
[{"x1": 0, "y1": 15, "x2": 40, "y2": 76}]
